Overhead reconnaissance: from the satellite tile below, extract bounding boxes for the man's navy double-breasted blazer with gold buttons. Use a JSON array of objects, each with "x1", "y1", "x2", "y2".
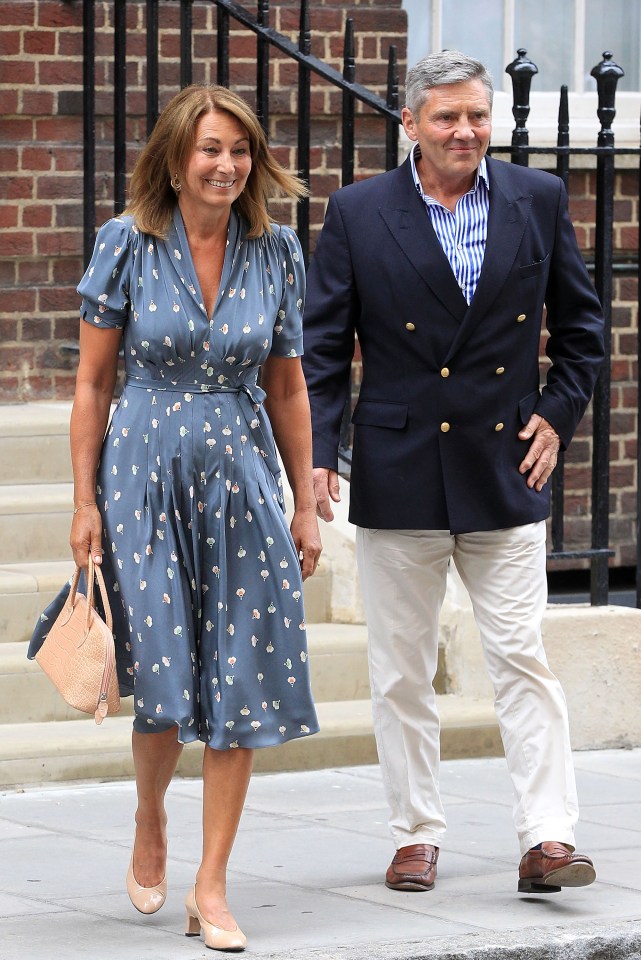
[{"x1": 303, "y1": 158, "x2": 604, "y2": 533}]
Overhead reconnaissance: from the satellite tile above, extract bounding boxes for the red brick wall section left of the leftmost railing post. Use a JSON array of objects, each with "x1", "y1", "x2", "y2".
[{"x1": 0, "y1": 0, "x2": 82, "y2": 401}]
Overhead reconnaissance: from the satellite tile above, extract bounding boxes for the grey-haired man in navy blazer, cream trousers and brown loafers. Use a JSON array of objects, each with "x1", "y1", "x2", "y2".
[{"x1": 304, "y1": 51, "x2": 603, "y2": 893}]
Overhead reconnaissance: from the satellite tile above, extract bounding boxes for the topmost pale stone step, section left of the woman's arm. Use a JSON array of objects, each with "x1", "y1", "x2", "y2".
[{"x1": 0, "y1": 402, "x2": 72, "y2": 484}]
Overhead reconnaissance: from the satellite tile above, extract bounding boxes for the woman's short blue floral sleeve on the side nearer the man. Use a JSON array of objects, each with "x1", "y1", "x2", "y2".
[{"x1": 271, "y1": 227, "x2": 305, "y2": 357}]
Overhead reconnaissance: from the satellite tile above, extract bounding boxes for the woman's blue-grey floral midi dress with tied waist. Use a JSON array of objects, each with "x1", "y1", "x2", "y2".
[{"x1": 31, "y1": 208, "x2": 318, "y2": 749}]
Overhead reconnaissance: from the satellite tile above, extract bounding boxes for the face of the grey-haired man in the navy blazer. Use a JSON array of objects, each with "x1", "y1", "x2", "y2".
[{"x1": 402, "y1": 80, "x2": 492, "y2": 185}]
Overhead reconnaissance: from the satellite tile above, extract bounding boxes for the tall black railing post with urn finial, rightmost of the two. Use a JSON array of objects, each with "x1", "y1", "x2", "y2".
[{"x1": 590, "y1": 51, "x2": 623, "y2": 606}]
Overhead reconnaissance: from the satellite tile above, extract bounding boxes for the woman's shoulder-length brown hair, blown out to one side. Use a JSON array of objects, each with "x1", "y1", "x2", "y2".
[{"x1": 125, "y1": 85, "x2": 308, "y2": 239}]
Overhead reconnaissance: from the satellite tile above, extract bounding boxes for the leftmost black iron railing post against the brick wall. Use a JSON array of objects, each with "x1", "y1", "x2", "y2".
[{"x1": 82, "y1": 0, "x2": 96, "y2": 266}]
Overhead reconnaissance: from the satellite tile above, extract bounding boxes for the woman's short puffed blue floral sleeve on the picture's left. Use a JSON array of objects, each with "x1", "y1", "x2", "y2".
[{"x1": 78, "y1": 217, "x2": 138, "y2": 328}]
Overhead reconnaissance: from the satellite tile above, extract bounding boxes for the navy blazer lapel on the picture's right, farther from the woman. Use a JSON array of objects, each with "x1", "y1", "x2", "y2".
[{"x1": 443, "y1": 158, "x2": 532, "y2": 363}]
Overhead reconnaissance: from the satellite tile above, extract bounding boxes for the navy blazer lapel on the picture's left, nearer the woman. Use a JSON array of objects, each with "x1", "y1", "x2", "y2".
[{"x1": 379, "y1": 159, "x2": 467, "y2": 322}]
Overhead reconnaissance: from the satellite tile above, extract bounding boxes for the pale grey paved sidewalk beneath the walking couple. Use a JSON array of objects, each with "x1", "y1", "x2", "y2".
[{"x1": 0, "y1": 750, "x2": 641, "y2": 960}]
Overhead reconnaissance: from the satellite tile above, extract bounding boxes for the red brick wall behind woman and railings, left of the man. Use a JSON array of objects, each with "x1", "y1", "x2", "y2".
[{"x1": 0, "y1": 0, "x2": 406, "y2": 403}]
